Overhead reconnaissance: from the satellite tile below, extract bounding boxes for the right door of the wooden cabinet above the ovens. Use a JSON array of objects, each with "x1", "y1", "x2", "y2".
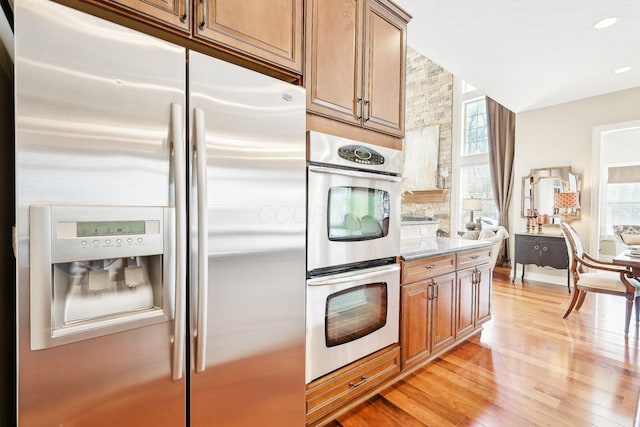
[{"x1": 362, "y1": 1, "x2": 407, "y2": 136}]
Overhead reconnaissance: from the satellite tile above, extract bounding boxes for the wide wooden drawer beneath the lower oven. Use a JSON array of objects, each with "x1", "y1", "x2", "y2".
[{"x1": 306, "y1": 345, "x2": 400, "y2": 423}]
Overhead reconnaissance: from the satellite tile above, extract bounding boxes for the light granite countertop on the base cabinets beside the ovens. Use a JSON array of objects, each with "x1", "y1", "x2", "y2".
[{"x1": 400, "y1": 237, "x2": 492, "y2": 261}]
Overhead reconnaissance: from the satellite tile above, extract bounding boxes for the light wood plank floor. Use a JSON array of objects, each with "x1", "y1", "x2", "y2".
[{"x1": 329, "y1": 269, "x2": 640, "y2": 427}]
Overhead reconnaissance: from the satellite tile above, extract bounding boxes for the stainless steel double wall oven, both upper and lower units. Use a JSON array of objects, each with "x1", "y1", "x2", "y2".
[{"x1": 306, "y1": 131, "x2": 402, "y2": 383}]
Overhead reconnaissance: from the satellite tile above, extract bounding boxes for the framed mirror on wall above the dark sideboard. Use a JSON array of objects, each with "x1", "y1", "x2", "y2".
[{"x1": 520, "y1": 166, "x2": 582, "y2": 224}]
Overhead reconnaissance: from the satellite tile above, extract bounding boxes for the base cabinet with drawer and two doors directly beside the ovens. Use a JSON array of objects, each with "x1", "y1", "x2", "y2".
[{"x1": 400, "y1": 254, "x2": 456, "y2": 369}]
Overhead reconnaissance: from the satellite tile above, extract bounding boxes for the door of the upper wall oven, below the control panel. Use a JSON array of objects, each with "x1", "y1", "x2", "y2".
[{"x1": 307, "y1": 165, "x2": 402, "y2": 272}]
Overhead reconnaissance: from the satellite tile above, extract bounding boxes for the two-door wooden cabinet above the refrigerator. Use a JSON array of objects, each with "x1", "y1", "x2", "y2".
[{"x1": 86, "y1": 0, "x2": 303, "y2": 74}]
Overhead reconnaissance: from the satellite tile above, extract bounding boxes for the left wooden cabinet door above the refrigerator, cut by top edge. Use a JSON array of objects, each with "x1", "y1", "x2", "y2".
[{"x1": 103, "y1": 0, "x2": 191, "y2": 33}]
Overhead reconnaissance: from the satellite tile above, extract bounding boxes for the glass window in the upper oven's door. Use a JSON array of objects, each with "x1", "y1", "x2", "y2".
[{"x1": 327, "y1": 187, "x2": 389, "y2": 241}]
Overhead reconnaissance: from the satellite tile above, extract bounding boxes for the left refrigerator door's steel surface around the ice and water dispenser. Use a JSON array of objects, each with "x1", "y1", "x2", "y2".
[{"x1": 14, "y1": 0, "x2": 186, "y2": 427}]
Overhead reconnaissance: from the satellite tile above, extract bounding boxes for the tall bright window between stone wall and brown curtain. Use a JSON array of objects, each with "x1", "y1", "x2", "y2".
[{"x1": 458, "y1": 82, "x2": 498, "y2": 229}]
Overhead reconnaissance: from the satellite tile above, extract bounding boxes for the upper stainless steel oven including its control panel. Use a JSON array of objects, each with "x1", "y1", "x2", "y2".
[{"x1": 307, "y1": 131, "x2": 402, "y2": 274}]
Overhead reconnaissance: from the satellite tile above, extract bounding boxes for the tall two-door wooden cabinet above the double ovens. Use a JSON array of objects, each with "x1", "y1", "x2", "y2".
[{"x1": 305, "y1": 0, "x2": 410, "y2": 136}]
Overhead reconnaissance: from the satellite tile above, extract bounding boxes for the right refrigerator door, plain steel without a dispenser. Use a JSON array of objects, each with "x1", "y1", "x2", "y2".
[{"x1": 189, "y1": 52, "x2": 306, "y2": 427}]
